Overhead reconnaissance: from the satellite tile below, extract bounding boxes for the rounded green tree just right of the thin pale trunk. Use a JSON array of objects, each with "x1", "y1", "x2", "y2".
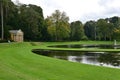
[{"x1": 97, "y1": 19, "x2": 114, "y2": 40}]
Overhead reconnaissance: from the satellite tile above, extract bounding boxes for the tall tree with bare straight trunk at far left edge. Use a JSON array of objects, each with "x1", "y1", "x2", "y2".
[{"x1": 0, "y1": 0, "x2": 12, "y2": 40}]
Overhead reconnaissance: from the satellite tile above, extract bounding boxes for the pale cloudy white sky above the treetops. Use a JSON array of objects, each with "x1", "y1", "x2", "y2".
[{"x1": 12, "y1": 0, "x2": 120, "y2": 23}]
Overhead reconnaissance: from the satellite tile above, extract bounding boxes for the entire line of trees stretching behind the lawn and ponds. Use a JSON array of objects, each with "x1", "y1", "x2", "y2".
[{"x1": 0, "y1": 0, "x2": 120, "y2": 41}]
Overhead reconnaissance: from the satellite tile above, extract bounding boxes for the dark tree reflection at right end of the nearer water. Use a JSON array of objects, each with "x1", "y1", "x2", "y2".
[{"x1": 98, "y1": 53, "x2": 120, "y2": 66}]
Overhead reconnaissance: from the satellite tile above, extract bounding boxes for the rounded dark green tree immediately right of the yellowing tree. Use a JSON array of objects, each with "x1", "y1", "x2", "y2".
[{"x1": 70, "y1": 21, "x2": 85, "y2": 41}]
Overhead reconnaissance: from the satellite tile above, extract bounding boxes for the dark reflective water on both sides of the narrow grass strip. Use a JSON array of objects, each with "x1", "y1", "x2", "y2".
[{"x1": 33, "y1": 44, "x2": 120, "y2": 68}]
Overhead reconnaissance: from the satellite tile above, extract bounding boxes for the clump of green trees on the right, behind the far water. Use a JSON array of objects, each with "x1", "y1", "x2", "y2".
[{"x1": 84, "y1": 17, "x2": 120, "y2": 41}]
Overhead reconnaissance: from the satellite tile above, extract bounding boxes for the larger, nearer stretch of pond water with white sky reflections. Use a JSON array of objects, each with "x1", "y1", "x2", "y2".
[{"x1": 33, "y1": 50, "x2": 120, "y2": 68}]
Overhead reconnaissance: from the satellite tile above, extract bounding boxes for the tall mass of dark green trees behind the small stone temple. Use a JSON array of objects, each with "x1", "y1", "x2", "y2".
[{"x1": 0, "y1": 0, "x2": 45, "y2": 41}]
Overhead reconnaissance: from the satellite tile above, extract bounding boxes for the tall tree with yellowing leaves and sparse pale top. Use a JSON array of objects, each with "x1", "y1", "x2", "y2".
[{"x1": 47, "y1": 10, "x2": 70, "y2": 41}]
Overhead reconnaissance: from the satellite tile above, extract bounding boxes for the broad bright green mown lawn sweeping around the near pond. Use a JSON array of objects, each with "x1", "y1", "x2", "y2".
[{"x1": 0, "y1": 41, "x2": 120, "y2": 80}]
